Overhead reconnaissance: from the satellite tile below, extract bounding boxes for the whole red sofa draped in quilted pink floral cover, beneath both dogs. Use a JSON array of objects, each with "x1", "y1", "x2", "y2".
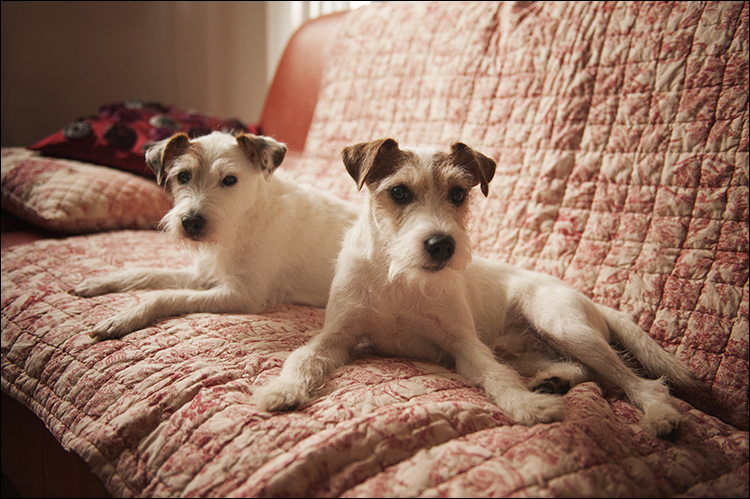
[{"x1": 2, "y1": 1, "x2": 749, "y2": 497}]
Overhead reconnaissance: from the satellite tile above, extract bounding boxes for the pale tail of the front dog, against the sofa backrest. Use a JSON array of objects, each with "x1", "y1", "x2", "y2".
[{"x1": 596, "y1": 304, "x2": 697, "y2": 388}]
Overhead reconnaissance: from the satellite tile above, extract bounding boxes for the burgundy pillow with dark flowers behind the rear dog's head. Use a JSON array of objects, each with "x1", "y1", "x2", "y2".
[{"x1": 29, "y1": 101, "x2": 260, "y2": 177}]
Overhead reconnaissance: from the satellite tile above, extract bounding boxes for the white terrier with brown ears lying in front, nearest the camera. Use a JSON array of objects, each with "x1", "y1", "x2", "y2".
[{"x1": 254, "y1": 139, "x2": 693, "y2": 436}]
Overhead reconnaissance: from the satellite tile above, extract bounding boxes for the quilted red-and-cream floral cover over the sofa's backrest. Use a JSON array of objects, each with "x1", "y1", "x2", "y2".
[{"x1": 287, "y1": 1, "x2": 748, "y2": 428}]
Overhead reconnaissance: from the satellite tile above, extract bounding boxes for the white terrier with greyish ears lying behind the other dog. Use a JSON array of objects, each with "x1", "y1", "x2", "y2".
[{"x1": 73, "y1": 132, "x2": 358, "y2": 340}]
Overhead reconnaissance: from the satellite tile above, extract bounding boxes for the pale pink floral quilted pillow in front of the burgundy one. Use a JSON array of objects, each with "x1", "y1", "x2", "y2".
[{"x1": 2, "y1": 147, "x2": 171, "y2": 234}]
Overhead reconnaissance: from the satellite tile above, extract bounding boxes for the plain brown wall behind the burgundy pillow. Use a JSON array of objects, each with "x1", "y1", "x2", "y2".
[{"x1": 2, "y1": 1, "x2": 272, "y2": 146}]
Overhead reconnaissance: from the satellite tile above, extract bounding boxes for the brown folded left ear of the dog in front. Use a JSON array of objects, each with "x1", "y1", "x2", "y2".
[{"x1": 341, "y1": 139, "x2": 401, "y2": 190}]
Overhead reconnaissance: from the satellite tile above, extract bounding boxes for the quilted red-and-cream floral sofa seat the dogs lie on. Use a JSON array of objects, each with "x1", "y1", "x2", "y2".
[{"x1": 0, "y1": 231, "x2": 748, "y2": 497}]
